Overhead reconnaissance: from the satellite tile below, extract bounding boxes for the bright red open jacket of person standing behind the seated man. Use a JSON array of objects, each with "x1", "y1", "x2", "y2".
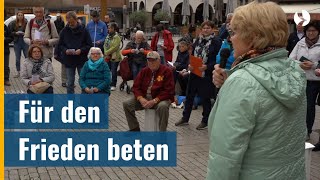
[{"x1": 151, "y1": 30, "x2": 174, "y2": 62}]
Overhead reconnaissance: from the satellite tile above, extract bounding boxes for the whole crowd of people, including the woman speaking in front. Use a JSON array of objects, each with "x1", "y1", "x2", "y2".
[{"x1": 4, "y1": 2, "x2": 320, "y2": 179}]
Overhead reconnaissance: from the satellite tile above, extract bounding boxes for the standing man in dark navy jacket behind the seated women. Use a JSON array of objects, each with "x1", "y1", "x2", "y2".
[{"x1": 58, "y1": 11, "x2": 92, "y2": 94}]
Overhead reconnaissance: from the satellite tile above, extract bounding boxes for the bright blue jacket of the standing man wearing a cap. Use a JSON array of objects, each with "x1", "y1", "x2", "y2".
[{"x1": 86, "y1": 20, "x2": 108, "y2": 46}]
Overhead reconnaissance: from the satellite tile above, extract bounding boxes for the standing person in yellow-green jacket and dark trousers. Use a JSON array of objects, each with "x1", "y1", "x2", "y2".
[{"x1": 104, "y1": 23, "x2": 121, "y2": 91}]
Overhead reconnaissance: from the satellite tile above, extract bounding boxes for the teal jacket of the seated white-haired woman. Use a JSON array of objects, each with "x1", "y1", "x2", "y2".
[{"x1": 79, "y1": 61, "x2": 111, "y2": 94}]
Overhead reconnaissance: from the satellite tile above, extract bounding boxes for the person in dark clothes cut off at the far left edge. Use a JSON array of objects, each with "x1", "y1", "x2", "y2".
[{"x1": 4, "y1": 25, "x2": 13, "y2": 86}]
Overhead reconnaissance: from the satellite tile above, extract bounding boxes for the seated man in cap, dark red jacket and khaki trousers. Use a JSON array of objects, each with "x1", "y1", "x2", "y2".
[{"x1": 123, "y1": 51, "x2": 174, "y2": 131}]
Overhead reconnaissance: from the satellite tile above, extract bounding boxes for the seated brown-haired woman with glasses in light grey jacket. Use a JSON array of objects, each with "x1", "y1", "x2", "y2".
[{"x1": 21, "y1": 45, "x2": 55, "y2": 94}]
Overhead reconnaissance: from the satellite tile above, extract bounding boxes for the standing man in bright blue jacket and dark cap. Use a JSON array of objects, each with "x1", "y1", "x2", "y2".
[{"x1": 87, "y1": 11, "x2": 108, "y2": 52}]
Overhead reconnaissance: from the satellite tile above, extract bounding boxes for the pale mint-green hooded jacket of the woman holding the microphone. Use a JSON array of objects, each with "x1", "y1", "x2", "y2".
[{"x1": 207, "y1": 49, "x2": 307, "y2": 180}]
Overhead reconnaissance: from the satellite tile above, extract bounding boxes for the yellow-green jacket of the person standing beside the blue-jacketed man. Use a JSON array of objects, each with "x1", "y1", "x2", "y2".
[{"x1": 104, "y1": 33, "x2": 122, "y2": 62}]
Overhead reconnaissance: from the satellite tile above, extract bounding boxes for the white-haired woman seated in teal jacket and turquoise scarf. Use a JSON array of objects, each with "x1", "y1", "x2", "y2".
[{"x1": 79, "y1": 47, "x2": 111, "y2": 94}]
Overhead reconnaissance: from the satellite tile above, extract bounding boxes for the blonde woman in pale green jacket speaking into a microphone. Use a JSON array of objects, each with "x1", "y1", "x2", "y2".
[{"x1": 207, "y1": 2, "x2": 307, "y2": 180}]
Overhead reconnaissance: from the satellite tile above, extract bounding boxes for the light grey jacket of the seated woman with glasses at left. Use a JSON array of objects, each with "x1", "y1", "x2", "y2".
[{"x1": 20, "y1": 58, "x2": 55, "y2": 86}]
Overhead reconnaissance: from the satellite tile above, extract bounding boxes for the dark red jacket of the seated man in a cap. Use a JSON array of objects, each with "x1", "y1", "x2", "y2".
[{"x1": 132, "y1": 64, "x2": 174, "y2": 102}]
